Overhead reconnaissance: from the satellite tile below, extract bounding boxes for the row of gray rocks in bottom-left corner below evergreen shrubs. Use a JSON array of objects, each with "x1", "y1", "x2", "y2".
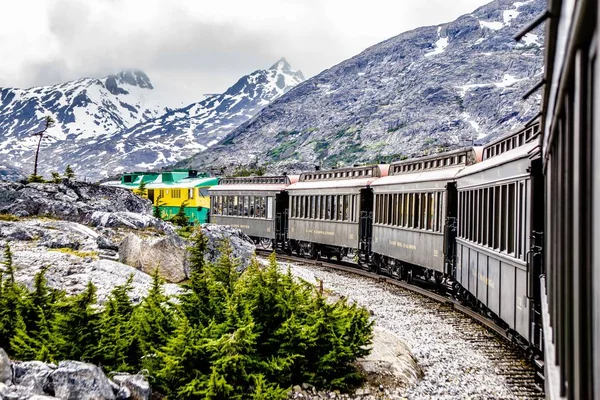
[{"x1": 0, "y1": 348, "x2": 150, "y2": 400}]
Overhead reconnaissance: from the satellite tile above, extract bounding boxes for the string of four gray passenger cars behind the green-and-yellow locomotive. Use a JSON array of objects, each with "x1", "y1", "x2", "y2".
[{"x1": 209, "y1": 122, "x2": 543, "y2": 358}]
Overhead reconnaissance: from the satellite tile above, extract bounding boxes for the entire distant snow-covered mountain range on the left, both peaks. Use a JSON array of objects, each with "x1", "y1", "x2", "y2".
[{"x1": 0, "y1": 58, "x2": 304, "y2": 179}]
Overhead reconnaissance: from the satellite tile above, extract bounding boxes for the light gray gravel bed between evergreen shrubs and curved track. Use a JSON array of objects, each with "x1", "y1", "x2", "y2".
[{"x1": 282, "y1": 263, "x2": 543, "y2": 399}]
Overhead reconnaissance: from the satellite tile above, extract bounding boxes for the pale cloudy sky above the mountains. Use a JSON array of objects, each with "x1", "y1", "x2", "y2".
[{"x1": 0, "y1": 0, "x2": 489, "y2": 107}]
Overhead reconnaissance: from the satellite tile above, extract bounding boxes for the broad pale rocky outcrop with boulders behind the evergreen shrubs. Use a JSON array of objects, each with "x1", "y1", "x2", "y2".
[{"x1": 0, "y1": 180, "x2": 254, "y2": 302}]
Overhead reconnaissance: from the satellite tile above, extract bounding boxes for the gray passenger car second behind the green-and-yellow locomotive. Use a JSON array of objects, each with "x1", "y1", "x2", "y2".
[{"x1": 288, "y1": 165, "x2": 388, "y2": 259}]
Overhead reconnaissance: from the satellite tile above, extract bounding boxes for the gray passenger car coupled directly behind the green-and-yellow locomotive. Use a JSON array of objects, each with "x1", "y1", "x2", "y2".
[{"x1": 209, "y1": 175, "x2": 298, "y2": 247}]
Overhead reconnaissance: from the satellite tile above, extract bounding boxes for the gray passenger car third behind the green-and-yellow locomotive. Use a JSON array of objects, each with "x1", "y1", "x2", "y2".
[{"x1": 371, "y1": 148, "x2": 477, "y2": 281}]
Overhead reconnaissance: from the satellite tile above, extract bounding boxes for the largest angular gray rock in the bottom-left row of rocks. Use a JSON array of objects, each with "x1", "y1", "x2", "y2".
[{"x1": 51, "y1": 361, "x2": 115, "y2": 400}]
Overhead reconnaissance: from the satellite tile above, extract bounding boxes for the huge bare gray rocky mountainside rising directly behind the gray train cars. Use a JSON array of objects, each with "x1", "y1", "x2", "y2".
[{"x1": 178, "y1": 0, "x2": 545, "y2": 170}]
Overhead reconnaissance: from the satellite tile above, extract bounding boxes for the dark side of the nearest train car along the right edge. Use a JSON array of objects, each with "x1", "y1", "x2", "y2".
[{"x1": 532, "y1": 0, "x2": 600, "y2": 399}]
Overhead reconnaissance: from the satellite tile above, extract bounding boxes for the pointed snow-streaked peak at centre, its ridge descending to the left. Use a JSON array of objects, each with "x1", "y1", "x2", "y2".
[{"x1": 88, "y1": 58, "x2": 304, "y2": 172}]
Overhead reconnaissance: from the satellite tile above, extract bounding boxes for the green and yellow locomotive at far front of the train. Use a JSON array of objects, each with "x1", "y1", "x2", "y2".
[{"x1": 113, "y1": 170, "x2": 219, "y2": 224}]
